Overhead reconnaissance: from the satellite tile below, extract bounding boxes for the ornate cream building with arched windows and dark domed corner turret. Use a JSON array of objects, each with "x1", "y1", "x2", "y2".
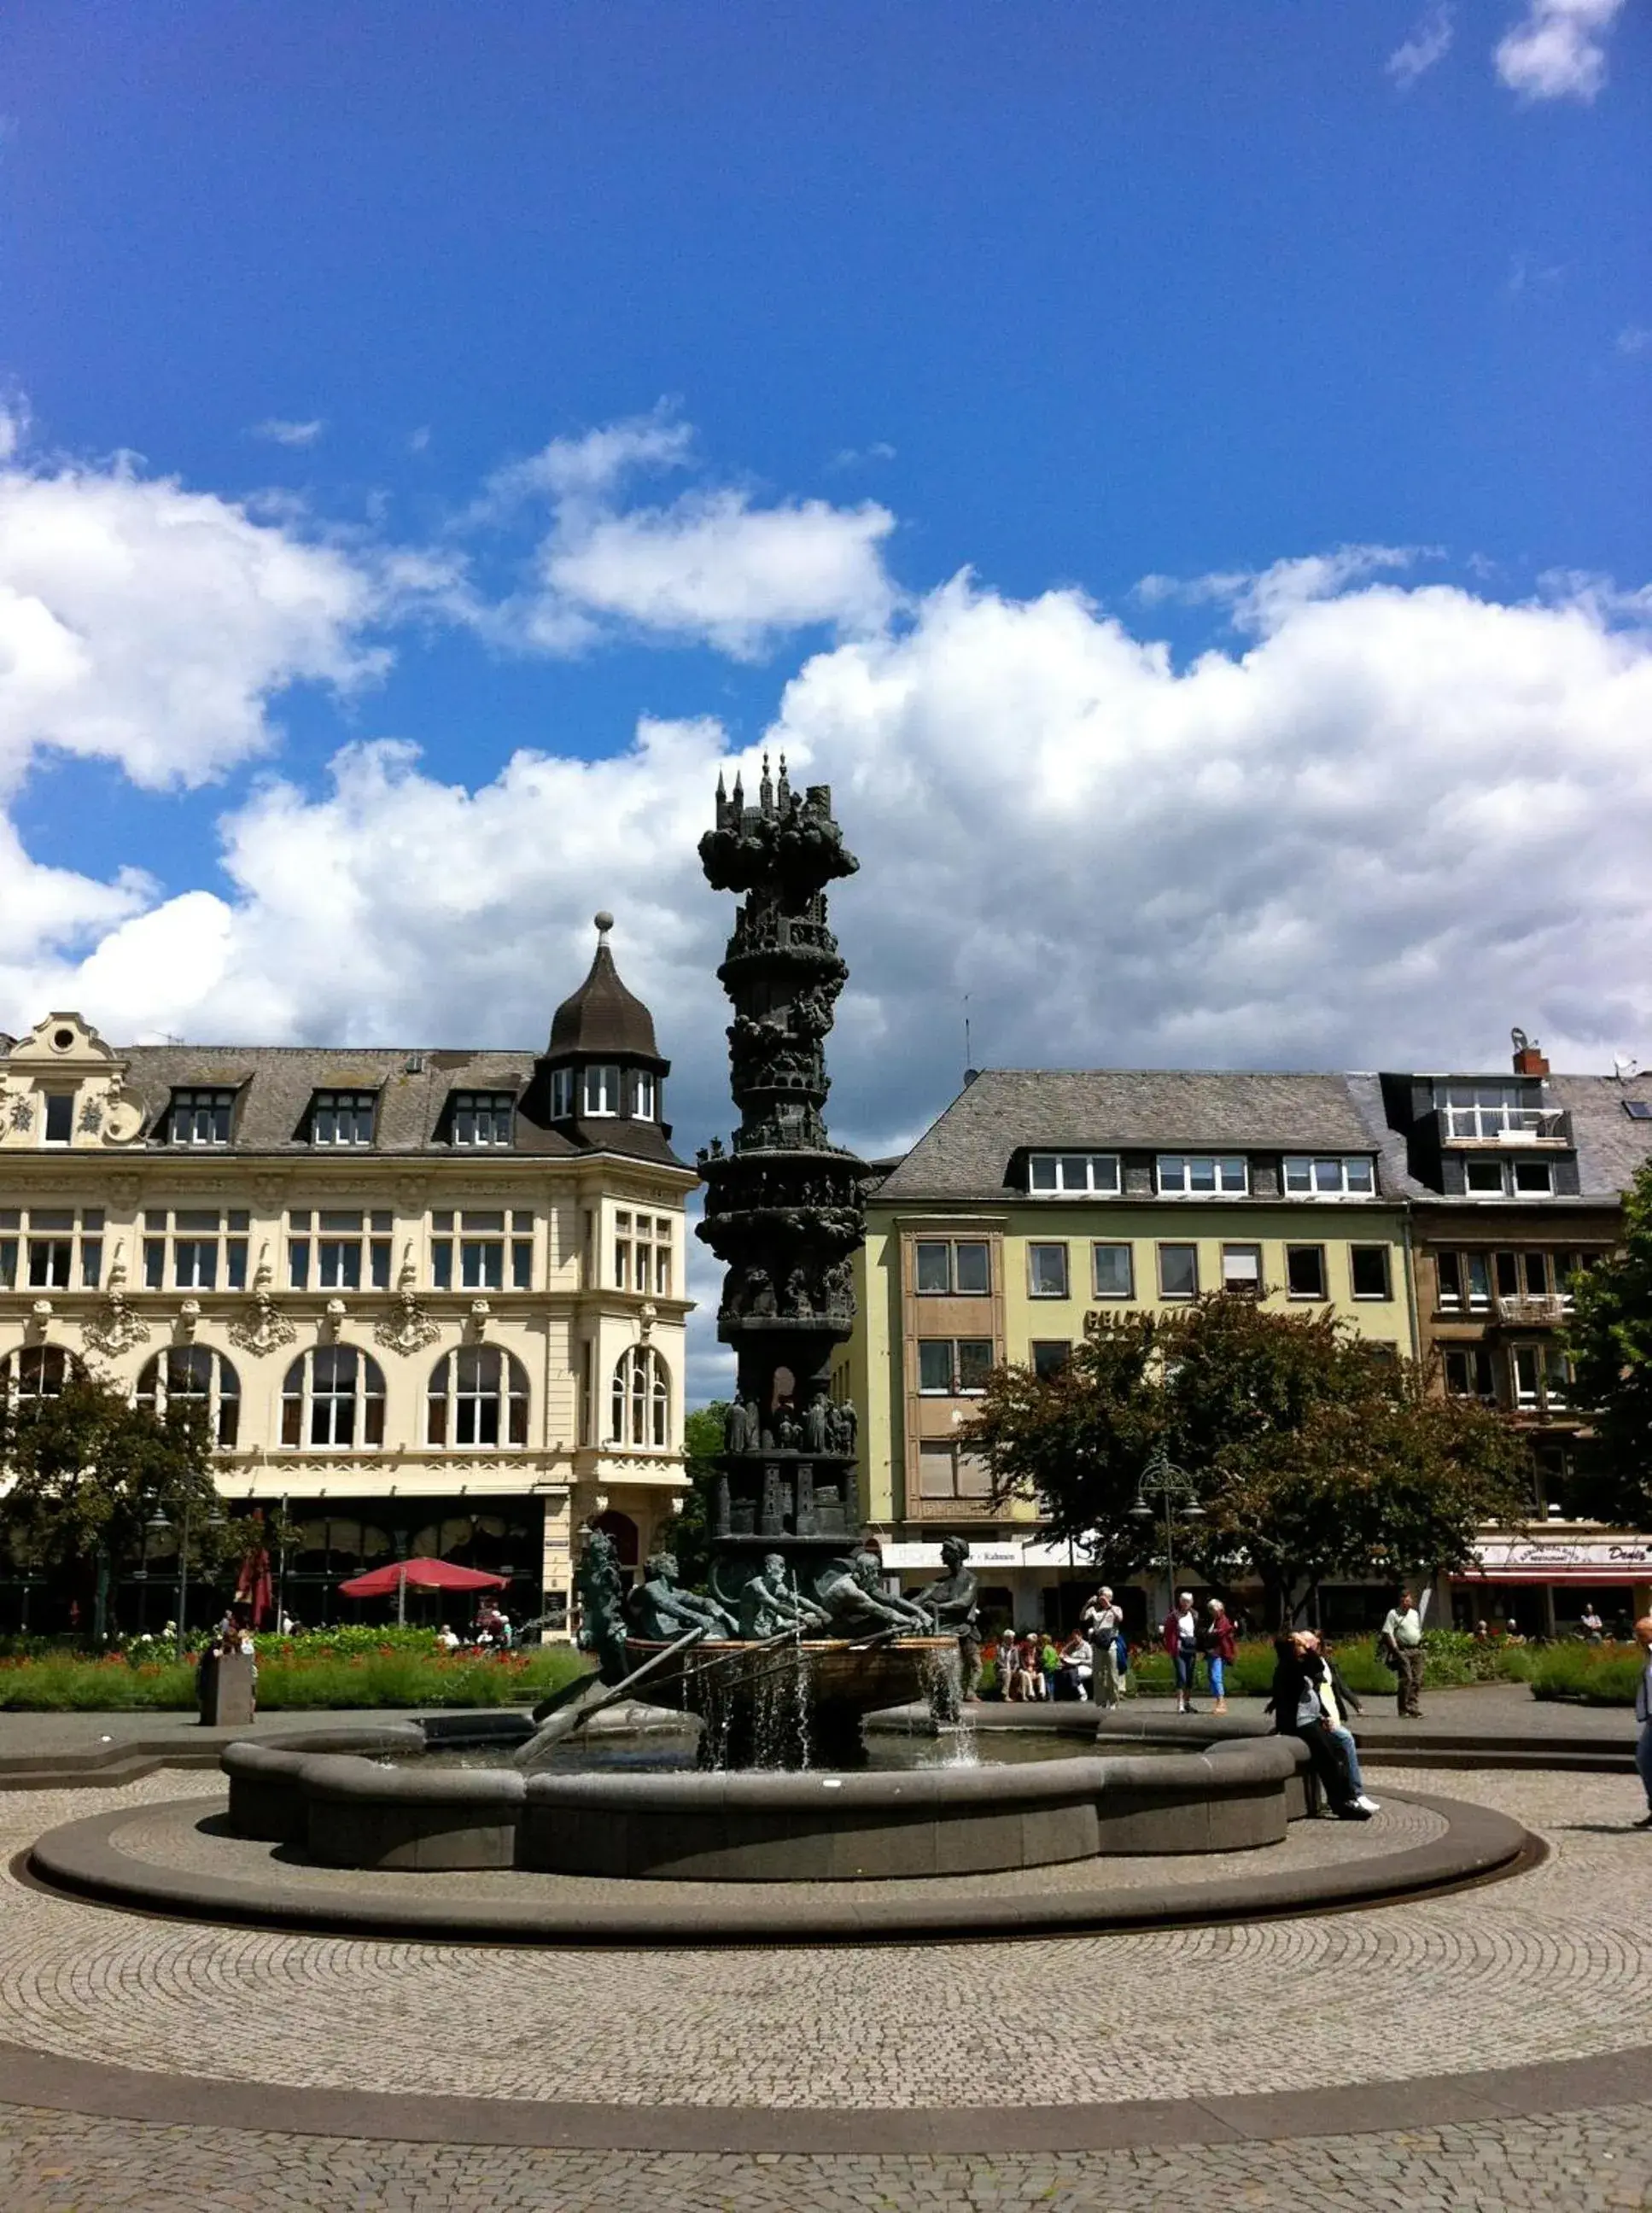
[{"x1": 0, "y1": 916, "x2": 697, "y2": 1631}]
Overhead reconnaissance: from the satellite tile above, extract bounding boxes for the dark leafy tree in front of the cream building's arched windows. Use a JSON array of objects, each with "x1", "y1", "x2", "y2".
[{"x1": 0, "y1": 1368, "x2": 265, "y2": 1638}]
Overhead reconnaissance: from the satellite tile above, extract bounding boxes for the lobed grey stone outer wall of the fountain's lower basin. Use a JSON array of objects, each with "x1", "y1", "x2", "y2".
[{"x1": 221, "y1": 1717, "x2": 1305, "y2": 1883}]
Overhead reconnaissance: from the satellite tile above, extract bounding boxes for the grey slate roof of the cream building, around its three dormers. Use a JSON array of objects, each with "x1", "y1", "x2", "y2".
[{"x1": 105, "y1": 1044, "x2": 683, "y2": 1166}]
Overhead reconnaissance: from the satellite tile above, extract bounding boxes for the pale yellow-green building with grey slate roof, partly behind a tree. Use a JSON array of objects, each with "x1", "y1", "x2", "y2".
[{"x1": 843, "y1": 1069, "x2": 1416, "y2": 1626}]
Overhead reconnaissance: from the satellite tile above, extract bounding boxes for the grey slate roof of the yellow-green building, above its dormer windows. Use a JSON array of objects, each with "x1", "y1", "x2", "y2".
[{"x1": 878, "y1": 1069, "x2": 1386, "y2": 1200}]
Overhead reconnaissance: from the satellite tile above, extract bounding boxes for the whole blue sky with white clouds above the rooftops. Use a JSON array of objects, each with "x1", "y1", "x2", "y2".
[{"x1": 0, "y1": 0, "x2": 1652, "y2": 1177}]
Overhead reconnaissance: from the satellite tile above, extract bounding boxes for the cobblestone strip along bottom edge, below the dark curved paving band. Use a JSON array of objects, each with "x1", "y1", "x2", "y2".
[{"x1": 0, "y1": 2107, "x2": 1652, "y2": 2213}]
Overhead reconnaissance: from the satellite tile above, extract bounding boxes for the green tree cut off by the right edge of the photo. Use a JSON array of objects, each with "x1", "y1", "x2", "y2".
[{"x1": 1566, "y1": 1159, "x2": 1652, "y2": 1529}]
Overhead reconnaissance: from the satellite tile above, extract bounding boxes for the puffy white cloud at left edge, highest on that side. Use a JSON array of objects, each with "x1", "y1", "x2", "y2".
[{"x1": 0, "y1": 444, "x2": 382, "y2": 792}]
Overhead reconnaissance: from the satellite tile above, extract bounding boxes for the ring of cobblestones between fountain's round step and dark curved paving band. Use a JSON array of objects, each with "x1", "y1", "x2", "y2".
[{"x1": 0, "y1": 1771, "x2": 1652, "y2": 2109}]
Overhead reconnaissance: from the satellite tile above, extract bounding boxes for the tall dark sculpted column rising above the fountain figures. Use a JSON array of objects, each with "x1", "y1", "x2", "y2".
[{"x1": 699, "y1": 755, "x2": 867, "y2": 1600}]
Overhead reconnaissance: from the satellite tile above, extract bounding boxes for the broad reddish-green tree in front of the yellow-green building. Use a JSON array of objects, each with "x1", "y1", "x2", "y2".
[{"x1": 962, "y1": 1294, "x2": 1531, "y2": 1620}]
